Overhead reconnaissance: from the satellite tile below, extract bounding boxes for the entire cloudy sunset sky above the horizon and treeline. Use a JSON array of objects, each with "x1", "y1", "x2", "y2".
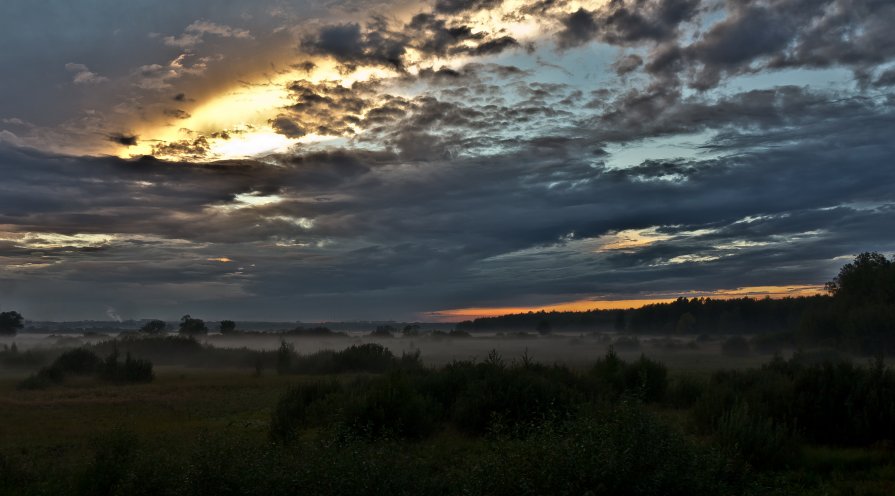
[{"x1": 0, "y1": 0, "x2": 895, "y2": 322}]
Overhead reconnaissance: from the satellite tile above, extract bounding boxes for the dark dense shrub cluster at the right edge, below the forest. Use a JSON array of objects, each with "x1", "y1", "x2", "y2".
[{"x1": 692, "y1": 354, "x2": 895, "y2": 465}]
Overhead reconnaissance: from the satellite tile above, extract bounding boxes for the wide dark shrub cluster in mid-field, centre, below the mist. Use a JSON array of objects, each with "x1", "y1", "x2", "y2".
[{"x1": 271, "y1": 345, "x2": 667, "y2": 440}]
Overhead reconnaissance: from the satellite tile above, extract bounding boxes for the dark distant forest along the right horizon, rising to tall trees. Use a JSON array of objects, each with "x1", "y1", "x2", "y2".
[{"x1": 457, "y1": 253, "x2": 895, "y2": 354}]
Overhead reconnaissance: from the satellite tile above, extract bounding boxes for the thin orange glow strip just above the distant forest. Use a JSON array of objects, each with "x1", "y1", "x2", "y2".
[{"x1": 424, "y1": 285, "x2": 824, "y2": 322}]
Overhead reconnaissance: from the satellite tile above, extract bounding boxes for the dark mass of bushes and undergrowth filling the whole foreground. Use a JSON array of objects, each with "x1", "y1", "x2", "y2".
[{"x1": 0, "y1": 345, "x2": 895, "y2": 495}]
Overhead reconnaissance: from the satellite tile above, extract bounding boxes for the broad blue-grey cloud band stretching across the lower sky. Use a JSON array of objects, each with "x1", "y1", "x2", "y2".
[{"x1": 0, "y1": 79, "x2": 895, "y2": 318}]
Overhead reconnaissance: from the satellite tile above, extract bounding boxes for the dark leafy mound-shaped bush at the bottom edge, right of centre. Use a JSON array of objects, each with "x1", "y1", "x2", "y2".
[{"x1": 464, "y1": 403, "x2": 744, "y2": 496}]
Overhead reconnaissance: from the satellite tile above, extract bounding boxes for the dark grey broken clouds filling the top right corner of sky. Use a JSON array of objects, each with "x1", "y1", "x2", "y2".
[{"x1": 554, "y1": 0, "x2": 895, "y2": 90}]
